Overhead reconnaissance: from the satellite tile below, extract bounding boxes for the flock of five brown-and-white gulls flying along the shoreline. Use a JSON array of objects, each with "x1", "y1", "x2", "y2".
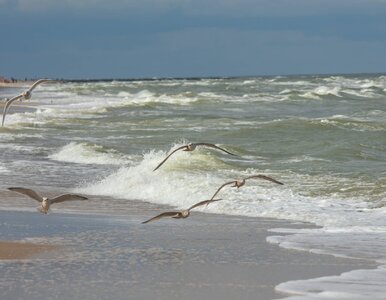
[{"x1": 2, "y1": 79, "x2": 283, "y2": 224}]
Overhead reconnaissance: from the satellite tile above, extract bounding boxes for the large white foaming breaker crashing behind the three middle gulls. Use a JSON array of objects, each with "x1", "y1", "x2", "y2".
[{"x1": 77, "y1": 145, "x2": 232, "y2": 207}]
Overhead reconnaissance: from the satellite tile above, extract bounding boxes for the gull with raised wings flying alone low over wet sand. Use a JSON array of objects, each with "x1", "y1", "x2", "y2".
[{"x1": 8, "y1": 187, "x2": 88, "y2": 214}]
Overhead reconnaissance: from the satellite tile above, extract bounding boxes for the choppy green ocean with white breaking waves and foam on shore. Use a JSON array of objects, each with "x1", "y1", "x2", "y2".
[{"x1": 0, "y1": 74, "x2": 386, "y2": 299}]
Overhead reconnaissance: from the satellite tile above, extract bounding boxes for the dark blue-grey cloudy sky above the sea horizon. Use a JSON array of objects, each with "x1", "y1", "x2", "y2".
[{"x1": 0, "y1": 0, "x2": 386, "y2": 79}]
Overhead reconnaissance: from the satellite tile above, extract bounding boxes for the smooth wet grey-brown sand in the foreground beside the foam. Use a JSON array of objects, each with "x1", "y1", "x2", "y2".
[{"x1": 0, "y1": 203, "x2": 375, "y2": 300}]
